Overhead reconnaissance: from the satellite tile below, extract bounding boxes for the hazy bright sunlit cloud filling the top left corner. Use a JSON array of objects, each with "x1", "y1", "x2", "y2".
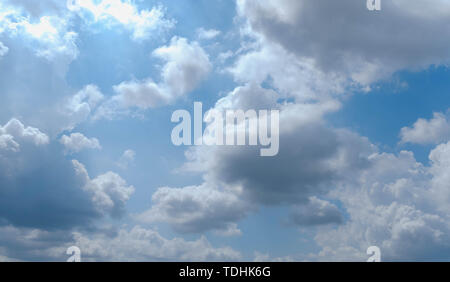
[{"x1": 0, "y1": 0, "x2": 79, "y2": 74}]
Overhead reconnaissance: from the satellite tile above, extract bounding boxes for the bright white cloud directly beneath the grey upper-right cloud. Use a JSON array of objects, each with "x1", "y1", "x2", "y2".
[{"x1": 227, "y1": 37, "x2": 350, "y2": 103}]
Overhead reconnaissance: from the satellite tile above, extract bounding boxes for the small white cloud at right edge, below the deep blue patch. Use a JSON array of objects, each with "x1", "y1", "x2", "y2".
[{"x1": 400, "y1": 113, "x2": 450, "y2": 145}]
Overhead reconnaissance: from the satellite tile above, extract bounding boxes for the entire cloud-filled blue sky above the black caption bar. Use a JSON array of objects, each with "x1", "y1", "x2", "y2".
[{"x1": 0, "y1": 0, "x2": 450, "y2": 261}]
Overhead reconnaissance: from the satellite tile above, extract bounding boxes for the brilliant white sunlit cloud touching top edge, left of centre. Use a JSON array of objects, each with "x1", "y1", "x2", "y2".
[{"x1": 68, "y1": 0, "x2": 175, "y2": 40}]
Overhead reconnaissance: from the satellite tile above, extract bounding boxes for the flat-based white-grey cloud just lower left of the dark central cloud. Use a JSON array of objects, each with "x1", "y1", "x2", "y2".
[{"x1": 137, "y1": 183, "x2": 251, "y2": 236}]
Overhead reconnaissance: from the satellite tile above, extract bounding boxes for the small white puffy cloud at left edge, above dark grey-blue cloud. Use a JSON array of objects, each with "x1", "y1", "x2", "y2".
[{"x1": 0, "y1": 118, "x2": 49, "y2": 151}]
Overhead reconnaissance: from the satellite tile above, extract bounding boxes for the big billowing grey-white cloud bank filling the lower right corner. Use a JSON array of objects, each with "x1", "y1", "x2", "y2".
[{"x1": 316, "y1": 143, "x2": 450, "y2": 261}]
